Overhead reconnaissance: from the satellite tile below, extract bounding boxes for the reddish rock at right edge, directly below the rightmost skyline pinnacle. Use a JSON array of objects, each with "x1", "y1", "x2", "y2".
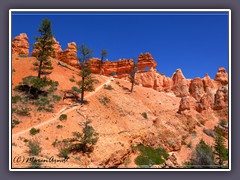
[{"x1": 214, "y1": 86, "x2": 228, "y2": 110}]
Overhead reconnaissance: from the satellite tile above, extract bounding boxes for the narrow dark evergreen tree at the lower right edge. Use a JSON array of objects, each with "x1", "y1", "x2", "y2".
[{"x1": 214, "y1": 126, "x2": 228, "y2": 166}]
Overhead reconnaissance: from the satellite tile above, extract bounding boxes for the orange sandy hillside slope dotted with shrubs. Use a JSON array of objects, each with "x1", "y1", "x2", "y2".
[{"x1": 12, "y1": 55, "x2": 229, "y2": 168}]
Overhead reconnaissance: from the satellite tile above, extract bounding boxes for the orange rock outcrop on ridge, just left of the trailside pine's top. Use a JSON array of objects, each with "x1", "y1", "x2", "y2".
[{"x1": 58, "y1": 42, "x2": 79, "y2": 68}]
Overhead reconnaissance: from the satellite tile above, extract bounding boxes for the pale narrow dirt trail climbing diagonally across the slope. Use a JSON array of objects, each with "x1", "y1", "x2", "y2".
[{"x1": 12, "y1": 78, "x2": 113, "y2": 138}]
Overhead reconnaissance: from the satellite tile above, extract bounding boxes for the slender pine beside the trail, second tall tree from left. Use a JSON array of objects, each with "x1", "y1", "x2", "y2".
[{"x1": 77, "y1": 44, "x2": 93, "y2": 104}]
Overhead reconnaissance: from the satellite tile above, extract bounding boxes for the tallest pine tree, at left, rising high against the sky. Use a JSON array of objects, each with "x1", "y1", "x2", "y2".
[{"x1": 34, "y1": 19, "x2": 54, "y2": 78}]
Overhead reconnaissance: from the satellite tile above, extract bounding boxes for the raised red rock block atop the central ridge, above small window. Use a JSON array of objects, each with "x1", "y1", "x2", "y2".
[{"x1": 138, "y1": 53, "x2": 157, "y2": 71}]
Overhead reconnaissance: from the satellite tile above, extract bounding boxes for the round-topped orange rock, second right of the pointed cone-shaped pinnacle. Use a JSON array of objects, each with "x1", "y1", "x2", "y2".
[{"x1": 189, "y1": 77, "x2": 205, "y2": 101}]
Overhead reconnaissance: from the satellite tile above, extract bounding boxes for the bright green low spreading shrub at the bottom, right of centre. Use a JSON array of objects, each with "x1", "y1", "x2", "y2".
[{"x1": 135, "y1": 145, "x2": 169, "y2": 168}]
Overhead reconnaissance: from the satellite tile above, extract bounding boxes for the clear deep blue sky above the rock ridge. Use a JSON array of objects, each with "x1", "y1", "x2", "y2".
[{"x1": 12, "y1": 12, "x2": 229, "y2": 78}]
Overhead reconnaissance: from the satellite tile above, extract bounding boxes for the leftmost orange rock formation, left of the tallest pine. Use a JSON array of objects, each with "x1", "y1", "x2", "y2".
[{"x1": 12, "y1": 33, "x2": 29, "y2": 56}]
